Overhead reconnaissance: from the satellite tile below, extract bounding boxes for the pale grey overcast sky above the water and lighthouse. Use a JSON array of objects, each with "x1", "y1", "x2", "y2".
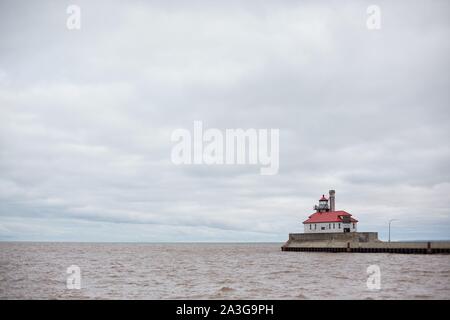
[{"x1": 0, "y1": 0, "x2": 450, "y2": 241}]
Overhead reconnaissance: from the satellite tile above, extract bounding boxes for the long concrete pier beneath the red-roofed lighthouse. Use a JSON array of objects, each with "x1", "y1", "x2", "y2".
[{"x1": 281, "y1": 232, "x2": 450, "y2": 254}]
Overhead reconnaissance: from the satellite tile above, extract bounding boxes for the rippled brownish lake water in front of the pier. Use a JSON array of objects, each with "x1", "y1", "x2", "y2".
[{"x1": 0, "y1": 242, "x2": 450, "y2": 299}]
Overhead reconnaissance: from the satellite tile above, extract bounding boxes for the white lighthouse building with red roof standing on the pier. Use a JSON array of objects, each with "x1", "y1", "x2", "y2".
[{"x1": 303, "y1": 190, "x2": 358, "y2": 233}]
